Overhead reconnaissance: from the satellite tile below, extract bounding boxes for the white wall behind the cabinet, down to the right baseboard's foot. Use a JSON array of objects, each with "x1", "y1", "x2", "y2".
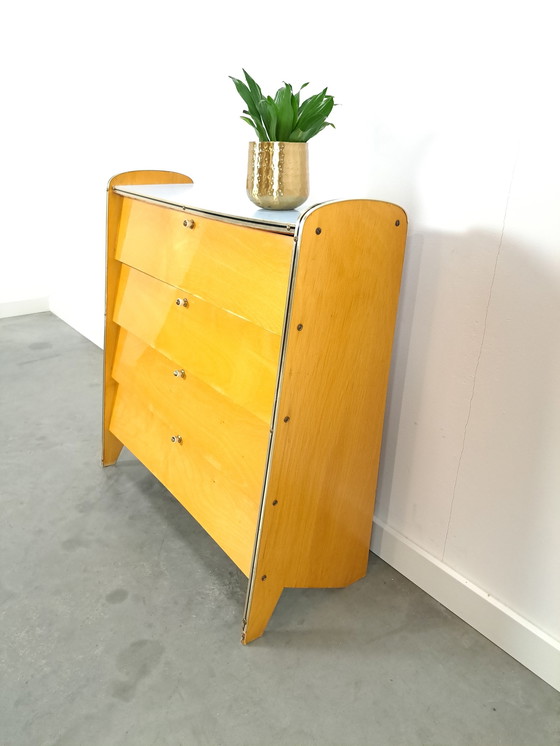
[{"x1": 4, "y1": 0, "x2": 560, "y2": 686}]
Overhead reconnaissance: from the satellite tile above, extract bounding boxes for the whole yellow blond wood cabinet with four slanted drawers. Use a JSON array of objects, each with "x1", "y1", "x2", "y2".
[{"x1": 103, "y1": 171, "x2": 407, "y2": 643}]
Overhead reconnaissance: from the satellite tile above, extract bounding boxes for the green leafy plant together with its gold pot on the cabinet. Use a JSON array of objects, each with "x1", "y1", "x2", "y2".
[{"x1": 230, "y1": 70, "x2": 335, "y2": 210}]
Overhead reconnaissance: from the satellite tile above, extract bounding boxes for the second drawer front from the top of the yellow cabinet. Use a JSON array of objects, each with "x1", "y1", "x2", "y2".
[{"x1": 114, "y1": 265, "x2": 280, "y2": 423}]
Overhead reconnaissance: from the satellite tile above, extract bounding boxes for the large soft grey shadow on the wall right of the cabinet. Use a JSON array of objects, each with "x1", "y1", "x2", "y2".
[{"x1": 376, "y1": 231, "x2": 560, "y2": 628}]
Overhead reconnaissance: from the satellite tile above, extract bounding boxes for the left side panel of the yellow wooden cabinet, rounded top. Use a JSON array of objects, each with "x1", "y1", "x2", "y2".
[{"x1": 101, "y1": 171, "x2": 192, "y2": 466}]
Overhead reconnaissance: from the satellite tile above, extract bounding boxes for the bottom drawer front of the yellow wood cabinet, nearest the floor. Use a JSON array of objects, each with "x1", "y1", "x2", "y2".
[{"x1": 110, "y1": 386, "x2": 260, "y2": 575}]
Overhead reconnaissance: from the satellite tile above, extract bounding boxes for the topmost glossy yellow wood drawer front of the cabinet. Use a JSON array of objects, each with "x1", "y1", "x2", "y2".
[{"x1": 116, "y1": 199, "x2": 293, "y2": 334}]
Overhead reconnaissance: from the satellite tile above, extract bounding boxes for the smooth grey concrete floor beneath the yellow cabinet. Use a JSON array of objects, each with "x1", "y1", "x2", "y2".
[{"x1": 0, "y1": 313, "x2": 560, "y2": 746}]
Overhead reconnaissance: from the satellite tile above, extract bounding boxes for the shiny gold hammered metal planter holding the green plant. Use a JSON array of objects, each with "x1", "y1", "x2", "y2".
[{"x1": 247, "y1": 142, "x2": 309, "y2": 210}]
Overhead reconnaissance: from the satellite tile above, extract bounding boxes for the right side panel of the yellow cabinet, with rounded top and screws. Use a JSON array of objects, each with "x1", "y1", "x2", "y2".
[{"x1": 245, "y1": 201, "x2": 406, "y2": 642}]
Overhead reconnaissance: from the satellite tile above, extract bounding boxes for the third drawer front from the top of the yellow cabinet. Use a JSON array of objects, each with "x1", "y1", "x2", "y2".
[{"x1": 113, "y1": 329, "x2": 269, "y2": 496}]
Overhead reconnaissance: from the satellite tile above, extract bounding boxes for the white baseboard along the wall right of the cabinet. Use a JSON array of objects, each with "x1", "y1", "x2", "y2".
[{"x1": 371, "y1": 519, "x2": 560, "y2": 691}]
